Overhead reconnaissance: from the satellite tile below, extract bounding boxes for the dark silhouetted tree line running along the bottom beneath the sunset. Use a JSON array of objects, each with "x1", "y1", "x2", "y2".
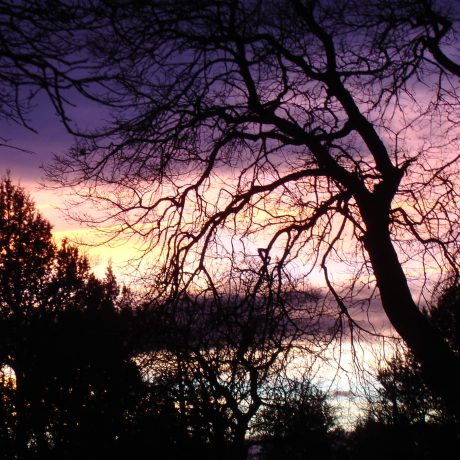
[{"x1": 0, "y1": 176, "x2": 460, "y2": 460}]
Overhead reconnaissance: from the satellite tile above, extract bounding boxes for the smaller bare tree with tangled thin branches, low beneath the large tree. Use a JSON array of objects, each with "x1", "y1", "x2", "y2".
[{"x1": 137, "y1": 272, "x2": 329, "y2": 460}]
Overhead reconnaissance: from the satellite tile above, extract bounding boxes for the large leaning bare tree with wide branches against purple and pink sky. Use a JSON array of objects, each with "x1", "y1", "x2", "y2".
[{"x1": 4, "y1": 0, "x2": 460, "y2": 413}]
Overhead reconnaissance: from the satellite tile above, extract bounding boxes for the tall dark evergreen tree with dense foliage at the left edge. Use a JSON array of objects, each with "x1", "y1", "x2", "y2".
[{"x1": 0, "y1": 176, "x2": 146, "y2": 459}]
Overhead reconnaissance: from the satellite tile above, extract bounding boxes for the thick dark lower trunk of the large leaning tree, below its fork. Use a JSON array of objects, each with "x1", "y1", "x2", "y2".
[{"x1": 365, "y1": 219, "x2": 460, "y2": 417}]
